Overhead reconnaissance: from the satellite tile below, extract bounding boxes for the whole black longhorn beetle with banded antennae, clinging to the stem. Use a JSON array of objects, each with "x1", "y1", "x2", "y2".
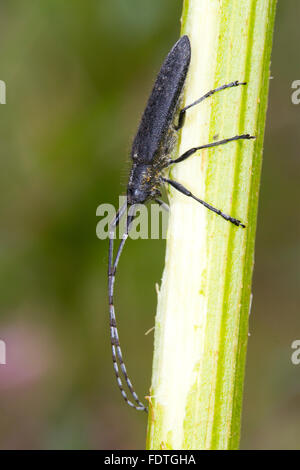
[{"x1": 108, "y1": 36, "x2": 255, "y2": 412}]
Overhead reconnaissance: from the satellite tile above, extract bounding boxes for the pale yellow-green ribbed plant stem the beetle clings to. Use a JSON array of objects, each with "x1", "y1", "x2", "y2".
[{"x1": 147, "y1": 0, "x2": 276, "y2": 449}]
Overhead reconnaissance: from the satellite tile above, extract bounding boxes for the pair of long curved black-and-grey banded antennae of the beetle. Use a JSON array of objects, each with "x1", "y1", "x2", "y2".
[{"x1": 108, "y1": 202, "x2": 148, "y2": 412}]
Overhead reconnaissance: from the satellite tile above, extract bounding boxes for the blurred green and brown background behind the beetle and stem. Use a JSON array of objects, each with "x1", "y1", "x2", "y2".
[{"x1": 0, "y1": 0, "x2": 300, "y2": 449}]
